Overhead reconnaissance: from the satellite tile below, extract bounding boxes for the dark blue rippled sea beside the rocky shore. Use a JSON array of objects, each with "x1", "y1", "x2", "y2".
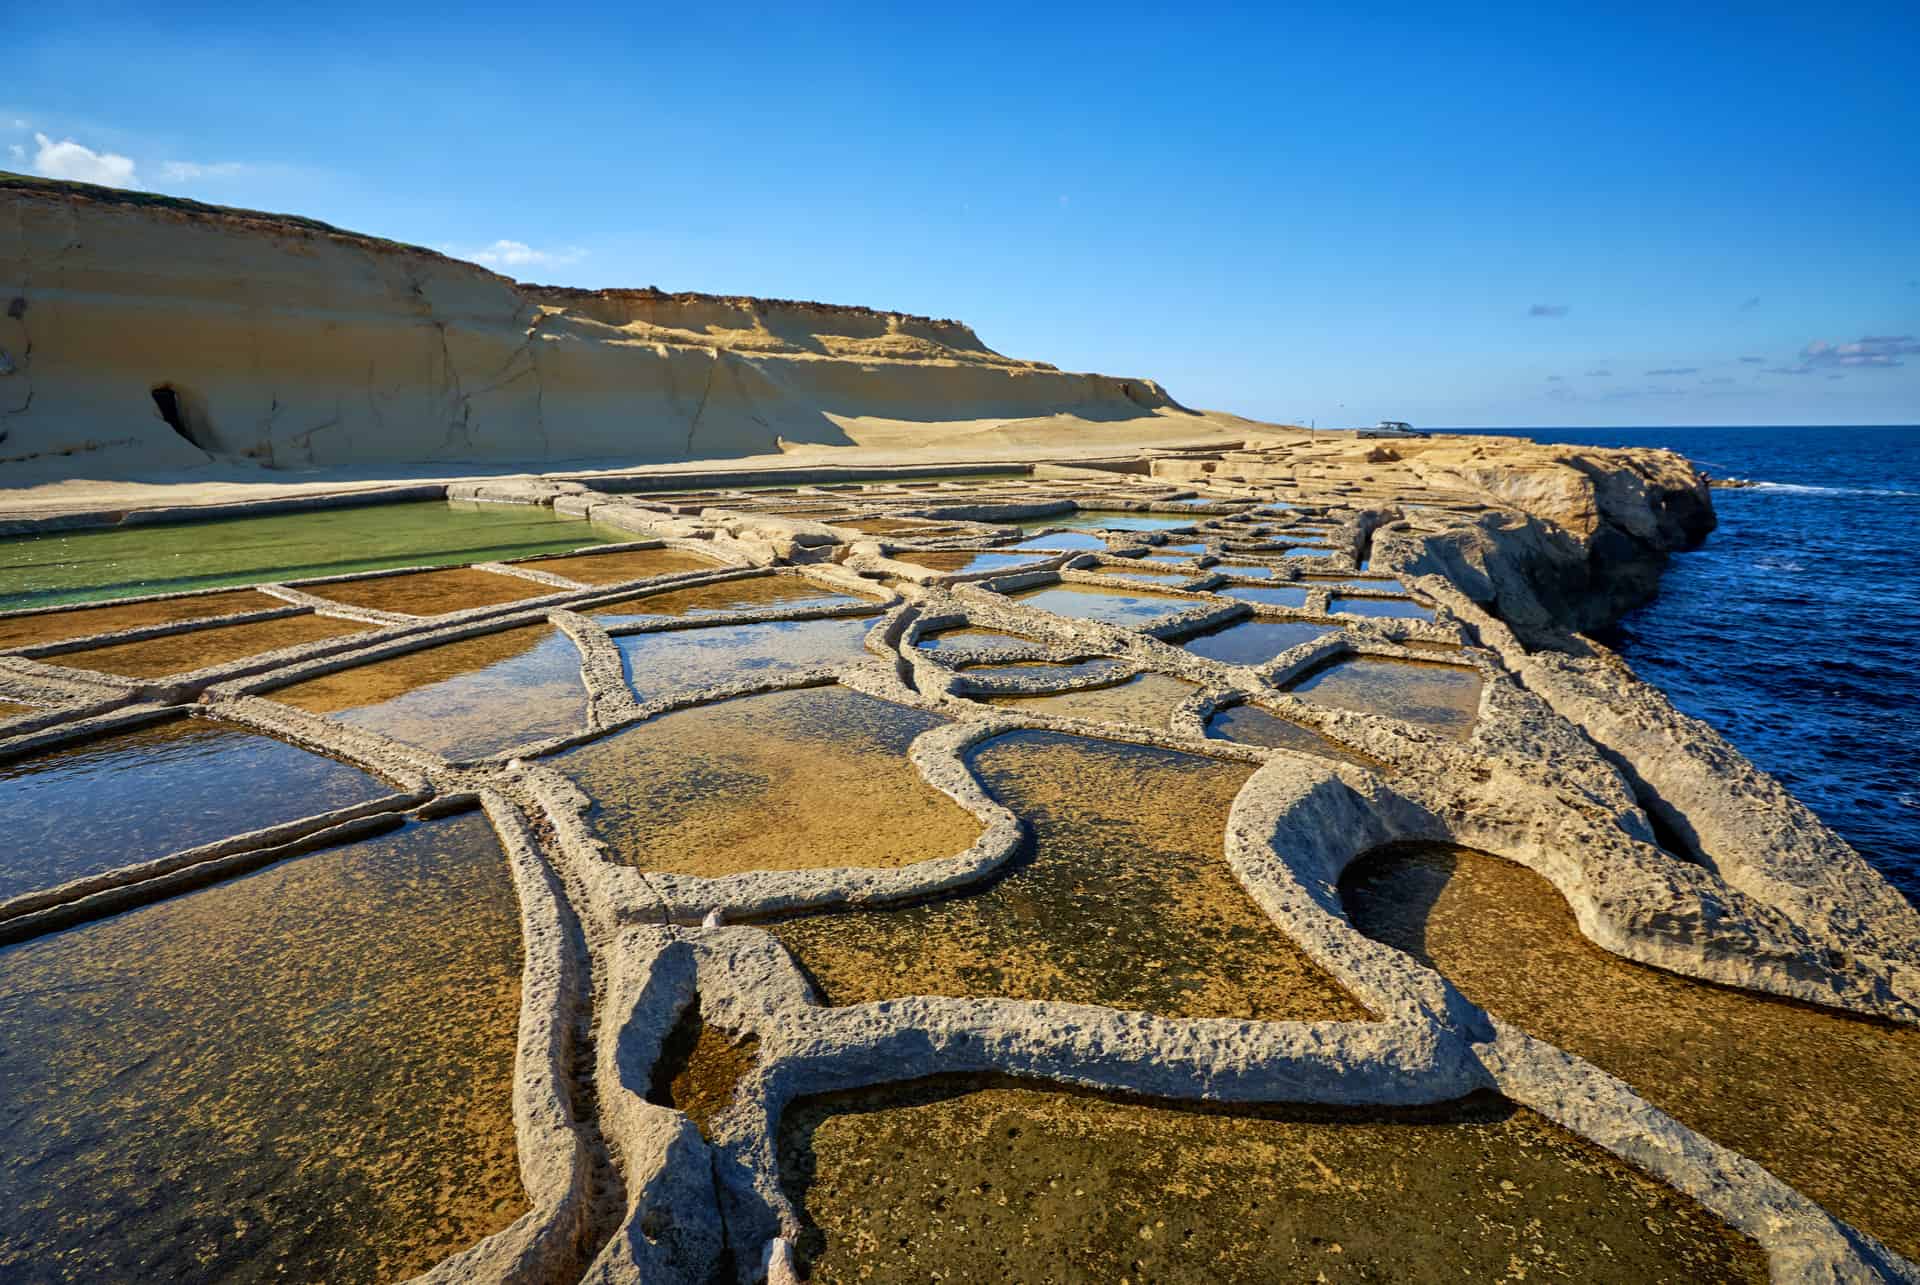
[{"x1": 1443, "y1": 426, "x2": 1920, "y2": 903}]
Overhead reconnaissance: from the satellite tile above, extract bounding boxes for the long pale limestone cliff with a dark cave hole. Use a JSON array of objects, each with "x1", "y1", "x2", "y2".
[{"x1": 0, "y1": 175, "x2": 1192, "y2": 484}]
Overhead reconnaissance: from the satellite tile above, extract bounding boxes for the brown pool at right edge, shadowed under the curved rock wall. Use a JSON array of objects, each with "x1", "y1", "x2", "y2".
[{"x1": 1340, "y1": 845, "x2": 1920, "y2": 1258}]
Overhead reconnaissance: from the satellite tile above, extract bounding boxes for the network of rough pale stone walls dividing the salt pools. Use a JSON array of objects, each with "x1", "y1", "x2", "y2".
[{"x1": 0, "y1": 466, "x2": 1920, "y2": 1281}]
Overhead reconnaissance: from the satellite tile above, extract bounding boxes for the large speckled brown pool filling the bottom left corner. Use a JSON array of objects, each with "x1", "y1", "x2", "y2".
[{"x1": 0, "y1": 814, "x2": 526, "y2": 1281}]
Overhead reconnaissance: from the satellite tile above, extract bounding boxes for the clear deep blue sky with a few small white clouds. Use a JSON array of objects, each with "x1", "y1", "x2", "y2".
[{"x1": 0, "y1": 2, "x2": 1920, "y2": 426}]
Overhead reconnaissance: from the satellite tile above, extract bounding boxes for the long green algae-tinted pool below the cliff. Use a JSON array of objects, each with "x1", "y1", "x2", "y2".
[{"x1": 0, "y1": 499, "x2": 628, "y2": 611}]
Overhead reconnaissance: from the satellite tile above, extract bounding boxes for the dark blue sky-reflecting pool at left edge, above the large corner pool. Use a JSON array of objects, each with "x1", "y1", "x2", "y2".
[{"x1": 0, "y1": 718, "x2": 394, "y2": 897}]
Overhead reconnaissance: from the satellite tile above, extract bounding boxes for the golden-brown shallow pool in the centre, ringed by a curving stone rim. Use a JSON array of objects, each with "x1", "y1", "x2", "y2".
[{"x1": 547, "y1": 686, "x2": 979, "y2": 876}]
